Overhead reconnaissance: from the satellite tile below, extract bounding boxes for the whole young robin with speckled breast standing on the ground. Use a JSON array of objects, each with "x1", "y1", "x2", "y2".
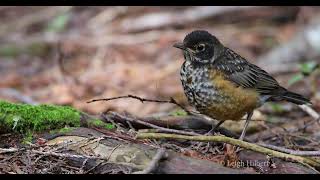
[{"x1": 173, "y1": 30, "x2": 311, "y2": 140}]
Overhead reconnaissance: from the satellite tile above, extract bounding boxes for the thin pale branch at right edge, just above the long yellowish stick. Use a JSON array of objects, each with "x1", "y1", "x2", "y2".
[{"x1": 258, "y1": 143, "x2": 320, "y2": 156}]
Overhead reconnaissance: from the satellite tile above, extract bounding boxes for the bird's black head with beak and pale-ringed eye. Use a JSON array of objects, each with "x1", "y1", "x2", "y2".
[{"x1": 173, "y1": 30, "x2": 223, "y2": 64}]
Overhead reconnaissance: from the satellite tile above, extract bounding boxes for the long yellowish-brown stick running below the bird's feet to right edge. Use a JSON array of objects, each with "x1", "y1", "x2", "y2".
[{"x1": 136, "y1": 133, "x2": 320, "y2": 168}]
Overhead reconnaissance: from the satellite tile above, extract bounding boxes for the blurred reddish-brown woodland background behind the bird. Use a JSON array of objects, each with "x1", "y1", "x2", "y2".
[{"x1": 0, "y1": 6, "x2": 320, "y2": 119}]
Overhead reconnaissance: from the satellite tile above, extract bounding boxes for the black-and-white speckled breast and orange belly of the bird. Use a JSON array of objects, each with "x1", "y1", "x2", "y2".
[{"x1": 180, "y1": 61, "x2": 258, "y2": 120}]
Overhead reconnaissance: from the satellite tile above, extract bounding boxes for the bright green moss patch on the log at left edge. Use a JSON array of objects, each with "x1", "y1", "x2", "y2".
[{"x1": 0, "y1": 101, "x2": 81, "y2": 133}]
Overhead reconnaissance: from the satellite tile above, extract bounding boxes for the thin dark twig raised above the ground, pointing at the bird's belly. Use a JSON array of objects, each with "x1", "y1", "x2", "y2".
[{"x1": 87, "y1": 94, "x2": 193, "y2": 114}]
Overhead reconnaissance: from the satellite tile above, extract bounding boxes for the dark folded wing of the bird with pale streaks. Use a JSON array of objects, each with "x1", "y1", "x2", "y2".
[{"x1": 215, "y1": 48, "x2": 280, "y2": 95}]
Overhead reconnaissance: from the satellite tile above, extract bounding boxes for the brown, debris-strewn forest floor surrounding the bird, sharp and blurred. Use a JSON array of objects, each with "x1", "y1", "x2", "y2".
[{"x1": 0, "y1": 6, "x2": 320, "y2": 173}]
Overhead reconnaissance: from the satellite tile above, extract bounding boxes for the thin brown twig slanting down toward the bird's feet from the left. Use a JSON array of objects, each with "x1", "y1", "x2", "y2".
[{"x1": 109, "y1": 112, "x2": 200, "y2": 136}]
